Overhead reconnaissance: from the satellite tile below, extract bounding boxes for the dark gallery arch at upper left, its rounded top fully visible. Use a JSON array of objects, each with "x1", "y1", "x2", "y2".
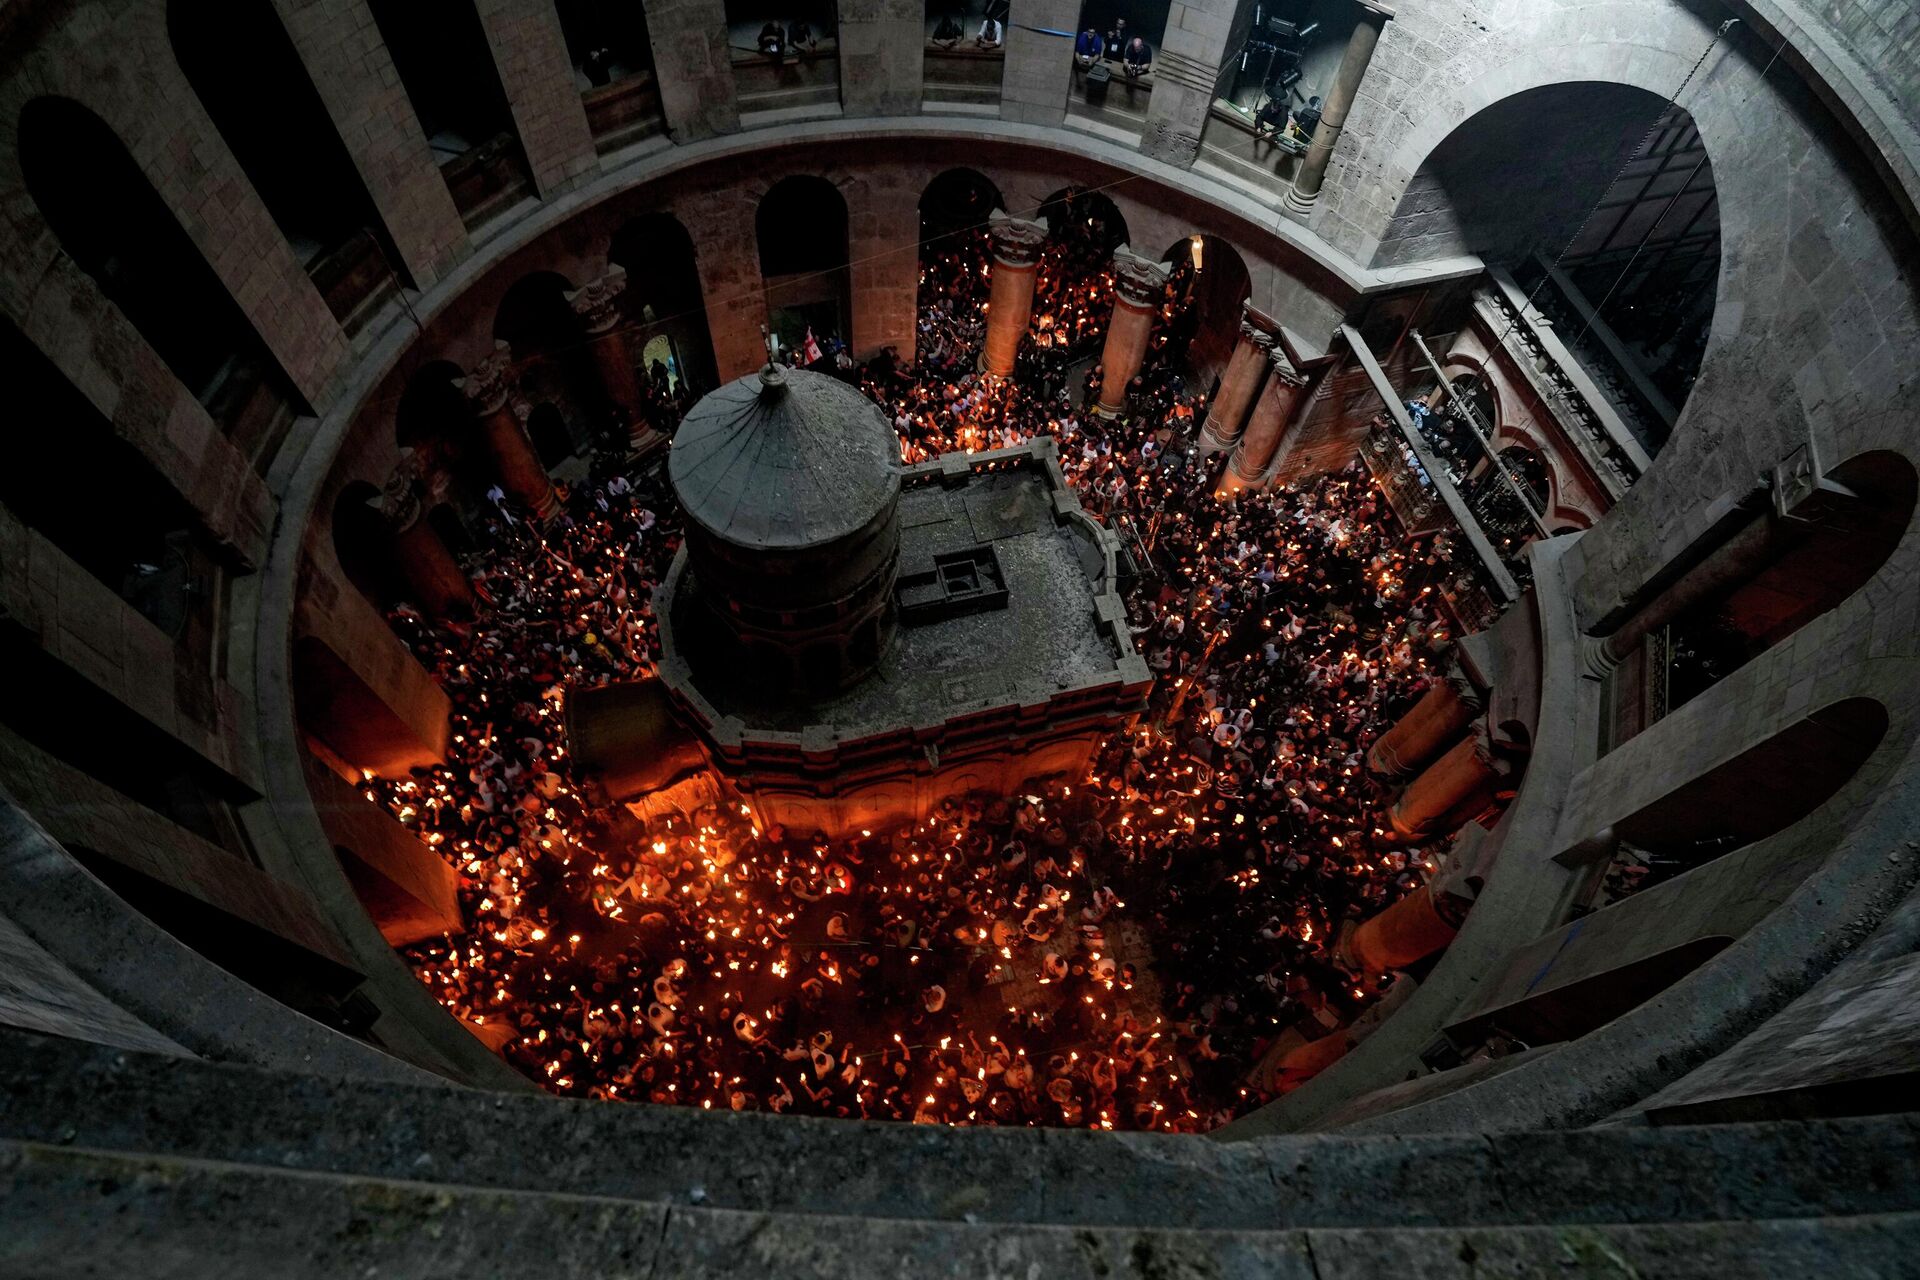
[{"x1": 19, "y1": 98, "x2": 298, "y2": 466}]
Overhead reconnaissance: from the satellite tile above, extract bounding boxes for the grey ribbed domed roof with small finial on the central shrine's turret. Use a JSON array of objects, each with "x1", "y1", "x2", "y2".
[{"x1": 666, "y1": 367, "x2": 900, "y2": 549}]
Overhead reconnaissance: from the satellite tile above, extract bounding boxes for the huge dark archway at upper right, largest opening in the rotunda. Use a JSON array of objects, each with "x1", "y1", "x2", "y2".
[{"x1": 1375, "y1": 81, "x2": 1720, "y2": 453}]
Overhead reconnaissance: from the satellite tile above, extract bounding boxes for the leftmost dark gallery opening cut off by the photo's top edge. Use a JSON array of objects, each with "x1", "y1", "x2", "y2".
[{"x1": 167, "y1": 0, "x2": 411, "y2": 330}]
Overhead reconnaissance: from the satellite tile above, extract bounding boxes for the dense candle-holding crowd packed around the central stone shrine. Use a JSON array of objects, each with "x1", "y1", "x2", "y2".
[{"x1": 367, "y1": 202, "x2": 1450, "y2": 1130}]
